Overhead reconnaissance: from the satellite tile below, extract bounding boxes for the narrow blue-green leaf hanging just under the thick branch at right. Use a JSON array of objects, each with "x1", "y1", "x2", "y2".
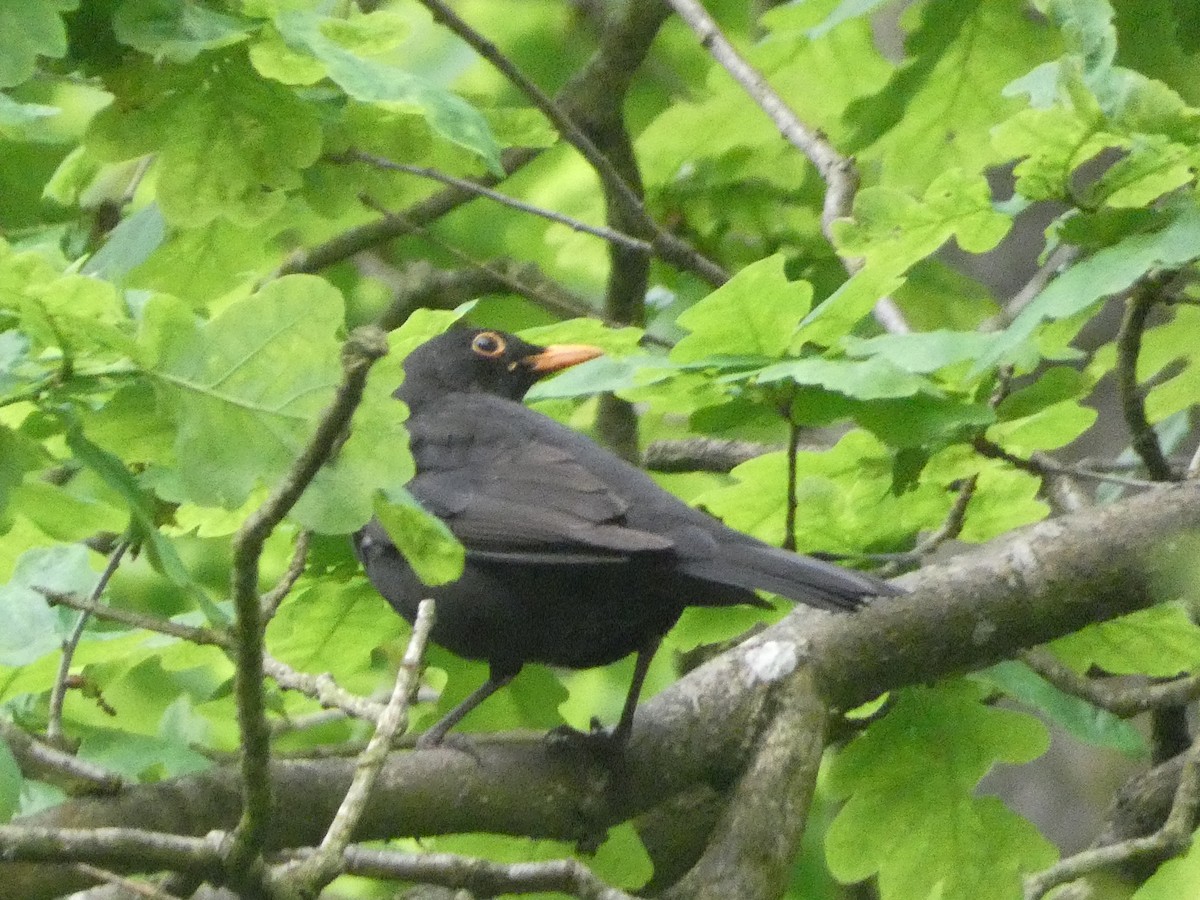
[{"x1": 971, "y1": 660, "x2": 1150, "y2": 760}]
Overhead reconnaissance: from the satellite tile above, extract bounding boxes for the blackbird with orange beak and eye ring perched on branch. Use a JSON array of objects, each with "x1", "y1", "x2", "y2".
[{"x1": 354, "y1": 326, "x2": 896, "y2": 748}]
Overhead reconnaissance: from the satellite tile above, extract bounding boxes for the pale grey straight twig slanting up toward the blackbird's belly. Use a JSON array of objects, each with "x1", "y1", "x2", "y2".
[{"x1": 280, "y1": 600, "x2": 434, "y2": 896}]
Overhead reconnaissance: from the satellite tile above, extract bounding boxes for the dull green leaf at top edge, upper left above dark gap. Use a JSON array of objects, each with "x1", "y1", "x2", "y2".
[{"x1": 113, "y1": 0, "x2": 252, "y2": 62}]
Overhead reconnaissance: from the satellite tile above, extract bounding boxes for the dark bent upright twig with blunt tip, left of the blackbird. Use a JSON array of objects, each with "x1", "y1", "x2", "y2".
[{"x1": 229, "y1": 326, "x2": 388, "y2": 887}]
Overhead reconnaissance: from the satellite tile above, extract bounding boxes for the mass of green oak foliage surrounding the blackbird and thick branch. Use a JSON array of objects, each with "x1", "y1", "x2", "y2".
[{"x1": 0, "y1": 0, "x2": 1200, "y2": 900}]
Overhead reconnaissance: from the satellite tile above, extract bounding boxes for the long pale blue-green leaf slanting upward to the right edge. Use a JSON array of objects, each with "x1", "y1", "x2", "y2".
[{"x1": 974, "y1": 200, "x2": 1200, "y2": 373}]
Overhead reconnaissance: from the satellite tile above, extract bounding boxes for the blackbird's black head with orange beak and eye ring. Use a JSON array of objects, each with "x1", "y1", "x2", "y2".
[{"x1": 396, "y1": 326, "x2": 604, "y2": 407}]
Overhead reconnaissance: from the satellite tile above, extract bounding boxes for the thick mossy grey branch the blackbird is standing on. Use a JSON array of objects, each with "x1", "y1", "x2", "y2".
[{"x1": 7, "y1": 482, "x2": 1200, "y2": 900}]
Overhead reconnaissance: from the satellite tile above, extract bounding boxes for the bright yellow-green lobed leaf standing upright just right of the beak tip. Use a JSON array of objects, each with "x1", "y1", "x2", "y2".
[{"x1": 671, "y1": 254, "x2": 812, "y2": 362}]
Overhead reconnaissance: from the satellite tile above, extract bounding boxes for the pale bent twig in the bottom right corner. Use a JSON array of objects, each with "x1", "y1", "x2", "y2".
[{"x1": 1025, "y1": 744, "x2": 1200, "y2": 900}]
